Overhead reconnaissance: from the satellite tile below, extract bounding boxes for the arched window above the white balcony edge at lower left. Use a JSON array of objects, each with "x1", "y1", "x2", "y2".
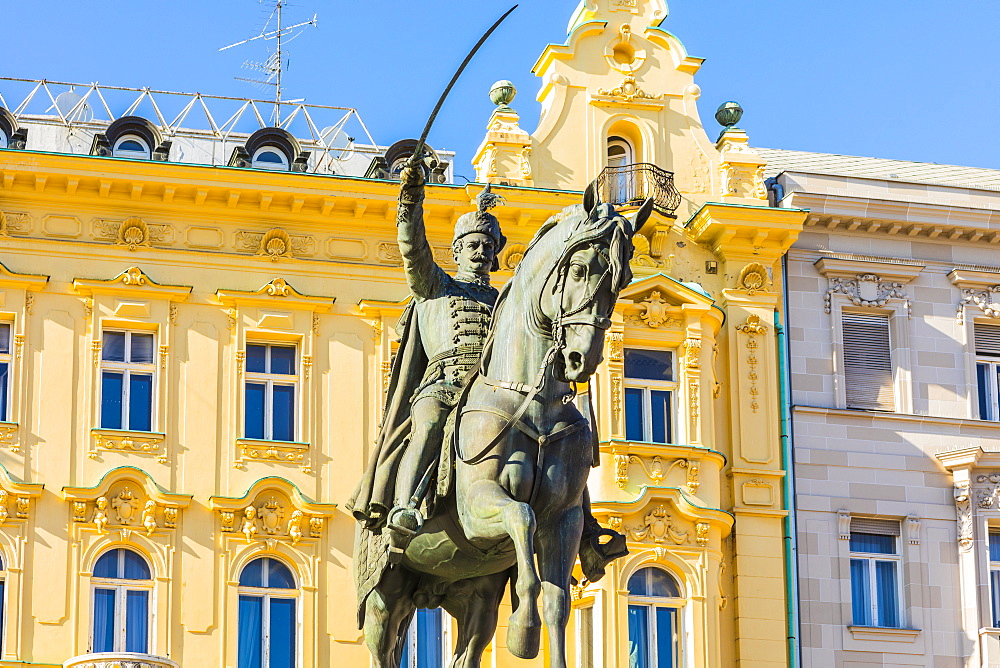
[{"x1": 91, "y1": 548, "x2": 153, "y2": 654}]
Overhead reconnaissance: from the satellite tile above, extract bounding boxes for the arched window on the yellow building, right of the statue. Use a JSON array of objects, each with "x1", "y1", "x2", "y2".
[{"x1": 628, "y1": 568, "x2": 684, "y2": 668}]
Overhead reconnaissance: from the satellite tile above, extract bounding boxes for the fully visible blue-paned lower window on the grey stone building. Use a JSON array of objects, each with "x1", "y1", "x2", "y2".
[{"x1": 850, "y1": 517, "x2": 903, "y2": 628}]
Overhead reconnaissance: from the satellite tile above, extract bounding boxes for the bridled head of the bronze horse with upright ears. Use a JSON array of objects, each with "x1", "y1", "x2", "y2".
[{"x1": 525, "y1": 182, "x2": 653, "y2": 382}]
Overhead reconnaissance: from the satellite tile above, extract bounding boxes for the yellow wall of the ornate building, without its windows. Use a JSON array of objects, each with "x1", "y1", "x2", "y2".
[{"x1": 0, "y1": 0, "x2": 804, "y2": 668}]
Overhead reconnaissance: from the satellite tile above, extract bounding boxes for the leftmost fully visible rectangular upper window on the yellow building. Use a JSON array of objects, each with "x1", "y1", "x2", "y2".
[{"x1": 100, "y1": 330, "x2": 156, "y2": 431}]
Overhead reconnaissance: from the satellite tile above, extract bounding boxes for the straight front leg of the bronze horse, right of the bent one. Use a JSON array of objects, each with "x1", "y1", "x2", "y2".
[{"x1": 538, "y1": 506, "x2": 583, "y2": 668}]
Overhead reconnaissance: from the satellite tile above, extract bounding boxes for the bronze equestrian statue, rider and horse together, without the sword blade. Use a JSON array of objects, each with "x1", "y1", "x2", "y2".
[{"x1": 349, "y1": 168, "x2": 640, "y2": 668}]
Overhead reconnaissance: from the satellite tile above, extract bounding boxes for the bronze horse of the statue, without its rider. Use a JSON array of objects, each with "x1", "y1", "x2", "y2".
[{"x1": 359, "y1": 184, "x2": 653, "y2": 668}]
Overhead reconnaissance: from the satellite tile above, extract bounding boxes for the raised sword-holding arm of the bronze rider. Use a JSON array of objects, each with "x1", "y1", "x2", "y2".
[{"x1": 396, "y1": 167, "x2": 443, "y2": 299}]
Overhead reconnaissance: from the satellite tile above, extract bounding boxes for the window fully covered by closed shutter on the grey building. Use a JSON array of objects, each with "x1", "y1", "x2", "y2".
[{"x1": 841, "y1": 312, "x2": 896, "y2": 411}]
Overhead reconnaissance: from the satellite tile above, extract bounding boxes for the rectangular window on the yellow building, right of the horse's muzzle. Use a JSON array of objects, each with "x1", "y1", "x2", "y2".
[{"x1": 625, "y1": 348, "x2": 676, "y2": 443}]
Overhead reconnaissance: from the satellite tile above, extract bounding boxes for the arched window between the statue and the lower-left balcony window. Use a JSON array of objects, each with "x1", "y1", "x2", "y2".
[{"x1": 238, "y1": 557, "x2": 298, "y2": 668}]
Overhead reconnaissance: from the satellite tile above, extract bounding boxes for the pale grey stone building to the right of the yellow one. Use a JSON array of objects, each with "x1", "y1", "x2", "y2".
[{"x1": 761, "y1": 150, "x2": 1000, "y2": 668}]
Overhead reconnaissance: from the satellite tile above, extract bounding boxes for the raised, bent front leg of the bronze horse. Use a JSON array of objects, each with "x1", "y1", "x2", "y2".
[{"x1": 459, "y1": 480, "x2": 542, "y2": 659}]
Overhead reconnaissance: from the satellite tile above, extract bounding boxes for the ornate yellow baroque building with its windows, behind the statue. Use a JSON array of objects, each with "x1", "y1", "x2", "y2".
[{"x1": 0, "y1": 0, "x2": 806, "y2": 668}]
